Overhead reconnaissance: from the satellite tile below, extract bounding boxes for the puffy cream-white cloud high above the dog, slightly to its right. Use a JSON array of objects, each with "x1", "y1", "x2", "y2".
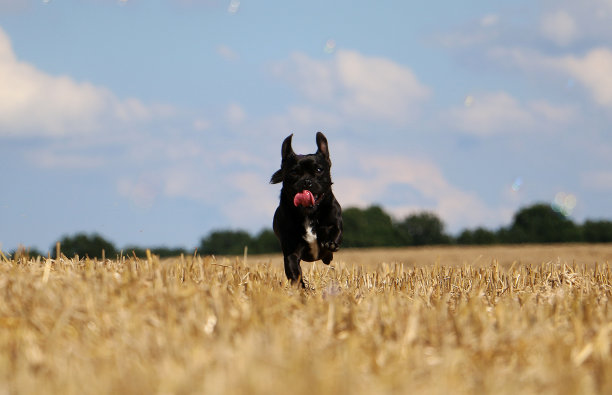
[{"x1": 274, "y1": 50, "x2": 431, "y2": 124}]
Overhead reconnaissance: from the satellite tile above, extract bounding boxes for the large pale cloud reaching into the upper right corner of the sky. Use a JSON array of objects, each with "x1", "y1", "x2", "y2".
[{"x1": 441, "y1": 0, "x2": 612, "y2": 108}]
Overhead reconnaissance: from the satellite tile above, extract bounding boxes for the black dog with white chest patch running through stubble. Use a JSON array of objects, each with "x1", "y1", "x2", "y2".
[{"x1": 270, "y1": 132, "x2": 342, "y2": 287}]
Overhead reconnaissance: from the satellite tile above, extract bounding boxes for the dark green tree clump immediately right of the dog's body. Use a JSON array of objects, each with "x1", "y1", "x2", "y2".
[{"x1": 342, "y1": 206, "x2": 399, "y2": 247}]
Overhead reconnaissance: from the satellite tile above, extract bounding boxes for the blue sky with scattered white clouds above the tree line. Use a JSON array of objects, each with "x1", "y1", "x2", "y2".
[{"x1": 0, "y1": 0, "x2": 612, "y2": 250}]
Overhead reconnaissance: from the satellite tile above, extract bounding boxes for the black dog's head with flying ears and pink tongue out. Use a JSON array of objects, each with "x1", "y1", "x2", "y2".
[{"x1": 270, "y1": 132, "x2": 332, "y2": 208}]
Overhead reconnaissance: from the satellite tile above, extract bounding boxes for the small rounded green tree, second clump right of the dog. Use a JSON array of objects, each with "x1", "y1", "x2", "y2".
[{"x1": 397, "y1": 212, "x2": 450, "y2": 246}]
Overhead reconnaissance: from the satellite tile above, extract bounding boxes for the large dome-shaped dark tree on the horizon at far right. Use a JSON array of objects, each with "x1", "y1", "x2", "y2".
[{"x1": 500, "y1": 203, "x2": 581, "y2": 243}]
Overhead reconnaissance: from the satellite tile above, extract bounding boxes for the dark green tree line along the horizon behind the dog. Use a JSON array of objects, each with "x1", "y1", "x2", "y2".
[{"x1": 12, "y1": 203, "x2": 612, "y2": 258}]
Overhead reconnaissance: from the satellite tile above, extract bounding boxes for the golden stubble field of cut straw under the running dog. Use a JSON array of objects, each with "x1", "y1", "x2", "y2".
[{"x1": 0, "y1": 245, "x2": 612, "y2": 394}]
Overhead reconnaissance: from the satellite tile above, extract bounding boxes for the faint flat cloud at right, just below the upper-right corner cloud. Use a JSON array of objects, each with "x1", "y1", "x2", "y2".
[{"x1": 447, "y1": 91, "x2": 576, "y2": 136}]
